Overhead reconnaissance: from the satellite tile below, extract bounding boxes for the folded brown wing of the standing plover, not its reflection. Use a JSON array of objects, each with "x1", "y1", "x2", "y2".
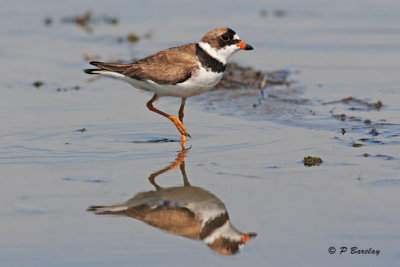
[{"x1": 122, "y1": 43, "x2": 198, "y2": 84}]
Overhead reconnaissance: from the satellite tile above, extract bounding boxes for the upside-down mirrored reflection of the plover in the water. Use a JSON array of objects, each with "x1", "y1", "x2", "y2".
[{"x1": 87, "y1": 149, "x2": 257, "y2": 255}]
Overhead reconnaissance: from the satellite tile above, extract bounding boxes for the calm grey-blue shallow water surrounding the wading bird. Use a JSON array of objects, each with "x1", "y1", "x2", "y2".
[{"x1": 0, "y1": 0, "x2": 400, "y2": 266}]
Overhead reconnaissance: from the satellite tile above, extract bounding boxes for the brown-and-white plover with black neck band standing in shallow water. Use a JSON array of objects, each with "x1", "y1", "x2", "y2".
[{"x1": 84, "y1": 28, "x2": 253, "y2": 145}]
